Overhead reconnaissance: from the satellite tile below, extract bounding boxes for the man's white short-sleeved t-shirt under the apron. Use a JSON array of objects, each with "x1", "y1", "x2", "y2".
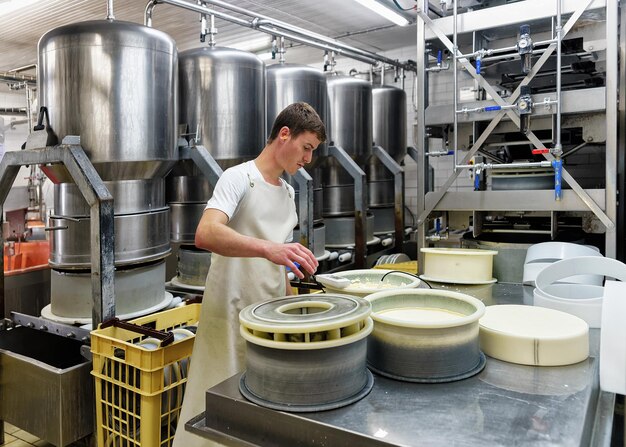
[{"x1": 205, "y1": 160, "x2": 295, "y2": 242}]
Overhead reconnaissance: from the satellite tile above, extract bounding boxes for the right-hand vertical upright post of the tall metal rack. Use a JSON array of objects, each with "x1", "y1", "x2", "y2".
[{"x1": 605, "y1": 1, "x2": 624, "y2": 258}]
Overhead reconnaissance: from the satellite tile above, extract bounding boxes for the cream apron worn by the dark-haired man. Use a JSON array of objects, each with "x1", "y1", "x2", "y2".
[{"x1": 173, "y1": 173, "x2": 297, "y2": 447}]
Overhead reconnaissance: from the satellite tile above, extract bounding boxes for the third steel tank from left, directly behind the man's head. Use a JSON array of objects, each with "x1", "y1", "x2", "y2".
[{"x1": 266, "y1": 64, "x2": 328, "y2": 228}]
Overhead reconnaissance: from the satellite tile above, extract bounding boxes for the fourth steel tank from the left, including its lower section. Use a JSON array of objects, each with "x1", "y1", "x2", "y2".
[{"x1": 321, "y1": 75, "x2": 372, "y2": 217}]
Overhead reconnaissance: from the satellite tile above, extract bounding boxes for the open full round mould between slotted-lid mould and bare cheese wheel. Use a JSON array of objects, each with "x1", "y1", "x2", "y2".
[{"x1": 366, "y1": 289, "x2": 485, "y2": 383}]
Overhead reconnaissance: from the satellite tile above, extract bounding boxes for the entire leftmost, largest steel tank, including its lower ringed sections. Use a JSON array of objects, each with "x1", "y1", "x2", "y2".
[{"x1": 38, "y1": 20, "x2": 178, "y2": 322}]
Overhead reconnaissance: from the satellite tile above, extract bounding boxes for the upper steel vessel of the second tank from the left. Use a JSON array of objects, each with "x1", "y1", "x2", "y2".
[{"x1": 179, "y1": 47, "x2": 266, "y2": 168}]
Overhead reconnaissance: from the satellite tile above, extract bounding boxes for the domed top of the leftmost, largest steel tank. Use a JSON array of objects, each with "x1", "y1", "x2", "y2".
[{"x1": 38, "y1": 20, "x2": 177, "y2": 54}]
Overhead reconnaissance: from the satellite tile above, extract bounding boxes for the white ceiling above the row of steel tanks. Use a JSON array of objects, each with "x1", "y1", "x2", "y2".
[{"x1": 0, "y1": 0, "x2": 415, "y2": 72}]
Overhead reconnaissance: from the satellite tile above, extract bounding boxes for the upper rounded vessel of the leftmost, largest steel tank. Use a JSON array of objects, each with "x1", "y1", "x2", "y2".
[{"x1": 37, "y1": 20, "x2": 178, "y2": 183}]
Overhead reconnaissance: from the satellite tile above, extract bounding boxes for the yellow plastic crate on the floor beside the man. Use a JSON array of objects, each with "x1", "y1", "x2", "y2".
[{"x1": 91, "y1": 304, "x2": 200, "y2": 447}]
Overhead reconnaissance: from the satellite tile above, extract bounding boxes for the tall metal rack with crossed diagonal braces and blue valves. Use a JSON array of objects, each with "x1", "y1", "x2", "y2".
[{"x1": 415, "y1": 0, "x2": 618, "y2": 265}]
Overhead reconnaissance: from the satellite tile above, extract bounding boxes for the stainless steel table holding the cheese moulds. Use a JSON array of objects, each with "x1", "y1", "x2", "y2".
[{"x1": 187, "y1": 284, "x2": 615, "y2": 447}]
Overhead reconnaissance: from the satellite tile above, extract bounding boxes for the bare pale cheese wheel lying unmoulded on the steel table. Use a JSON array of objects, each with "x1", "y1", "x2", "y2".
[{"x1": 479, "y1": 304, "x2": 589, "y2": 366}]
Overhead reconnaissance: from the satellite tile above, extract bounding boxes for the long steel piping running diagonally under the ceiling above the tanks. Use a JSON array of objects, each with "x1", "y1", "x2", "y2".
[{"x1": 144, "y1": 0, "x2": 416, "y2": 71}]
